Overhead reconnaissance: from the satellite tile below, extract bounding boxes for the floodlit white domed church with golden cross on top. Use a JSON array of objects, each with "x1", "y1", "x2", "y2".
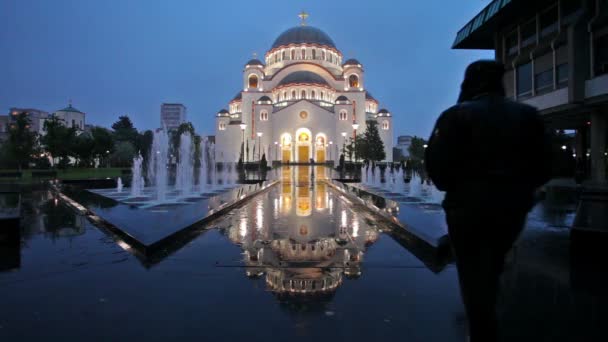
[{"x1": 215, "y1": 13, "x2": 393, "y2": 163}]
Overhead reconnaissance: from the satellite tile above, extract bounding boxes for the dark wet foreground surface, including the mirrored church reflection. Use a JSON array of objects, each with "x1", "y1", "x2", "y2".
[{"x1": 0, "y1": 167, "x2": 608, "y2": 341}]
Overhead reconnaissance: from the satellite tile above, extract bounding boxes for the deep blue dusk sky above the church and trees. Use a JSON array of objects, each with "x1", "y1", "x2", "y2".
[{"x1": 0, "y1": 0, "x2": 493, "y2": 137}]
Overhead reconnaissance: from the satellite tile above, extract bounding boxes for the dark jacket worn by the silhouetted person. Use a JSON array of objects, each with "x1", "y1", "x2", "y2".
[{"x1": 425, "y1": 94, "x2": 551, "y2": 210}]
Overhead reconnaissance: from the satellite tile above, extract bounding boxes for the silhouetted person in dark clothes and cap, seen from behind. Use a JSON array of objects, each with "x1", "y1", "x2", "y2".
[{"x1": 425, "y1": 61, "x2": 550, "y2": 342}]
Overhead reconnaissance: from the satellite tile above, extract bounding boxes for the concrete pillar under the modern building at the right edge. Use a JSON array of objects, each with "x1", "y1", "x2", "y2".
[{"x1": 590, "y1": 110, "x2": 608, "y2": 183}]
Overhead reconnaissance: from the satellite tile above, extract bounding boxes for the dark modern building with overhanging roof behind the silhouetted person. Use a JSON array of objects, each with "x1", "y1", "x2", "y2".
[{"x1": 453, "y1": 0, "x2": 608, "y2": 182}]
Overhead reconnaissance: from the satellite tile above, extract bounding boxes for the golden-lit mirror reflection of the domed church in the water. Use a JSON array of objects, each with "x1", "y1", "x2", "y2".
[{"x1": 228, "y1": 166, "x2": 379, "y2": 295}]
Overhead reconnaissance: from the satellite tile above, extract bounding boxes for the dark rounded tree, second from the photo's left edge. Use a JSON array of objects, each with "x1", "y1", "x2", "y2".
[{"x1": 41, "y1": 115, "x2": 76, "y2": 167}]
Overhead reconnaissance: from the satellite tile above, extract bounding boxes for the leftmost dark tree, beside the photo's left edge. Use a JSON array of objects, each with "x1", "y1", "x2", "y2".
[{"x1": 5, "y1": 113, "x2": 38, "y2": 170}]
